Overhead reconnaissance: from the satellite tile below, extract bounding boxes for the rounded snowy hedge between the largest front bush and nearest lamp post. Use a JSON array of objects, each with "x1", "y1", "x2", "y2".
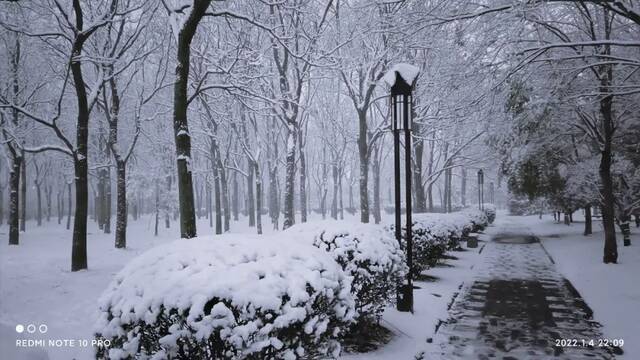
[{"x1": 282, "y1": 221, "x2": 407, "y2": 323}]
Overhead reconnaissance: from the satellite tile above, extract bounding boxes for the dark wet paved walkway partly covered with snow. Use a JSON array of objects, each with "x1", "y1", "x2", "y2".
[{"x1": 426, "y1": 219, "x2": 614, "y2": 360}]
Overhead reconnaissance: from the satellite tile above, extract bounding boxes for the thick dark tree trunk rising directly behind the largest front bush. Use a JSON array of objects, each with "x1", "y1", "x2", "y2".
[{"x1": 173, "y1": 0, "x2": 211, "y2": 239}]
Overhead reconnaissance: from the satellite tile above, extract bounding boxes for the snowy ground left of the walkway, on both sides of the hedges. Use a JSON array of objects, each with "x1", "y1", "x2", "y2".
[{"x1": 0, "y1": 212, "x2": 484, "y2": 360}]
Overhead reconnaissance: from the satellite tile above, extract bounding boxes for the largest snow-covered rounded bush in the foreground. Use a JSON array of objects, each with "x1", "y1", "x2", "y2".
[{"x1": 96, "y1": 235, "x2": 355, "y2": 359}]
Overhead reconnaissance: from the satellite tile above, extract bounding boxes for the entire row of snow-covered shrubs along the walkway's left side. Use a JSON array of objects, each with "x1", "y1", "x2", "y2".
[{"x1": 95, "y1": 209, "x2": 495, "y2": 359}]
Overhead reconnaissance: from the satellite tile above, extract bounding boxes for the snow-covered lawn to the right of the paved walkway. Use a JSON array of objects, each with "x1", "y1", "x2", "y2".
[{"x1": 523, "y1": 213, "x2": 640, "y2": 360}]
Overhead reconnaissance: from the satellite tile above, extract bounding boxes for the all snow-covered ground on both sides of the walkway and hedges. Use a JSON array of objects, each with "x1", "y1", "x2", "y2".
[{"x1": 0, "y1": 214, "x2": 640, "y2": 360}]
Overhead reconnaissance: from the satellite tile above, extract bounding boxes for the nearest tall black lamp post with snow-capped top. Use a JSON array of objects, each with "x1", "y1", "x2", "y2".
[{"x1": 383, "y1": 64, "x2": 419, "y2": 311}]
